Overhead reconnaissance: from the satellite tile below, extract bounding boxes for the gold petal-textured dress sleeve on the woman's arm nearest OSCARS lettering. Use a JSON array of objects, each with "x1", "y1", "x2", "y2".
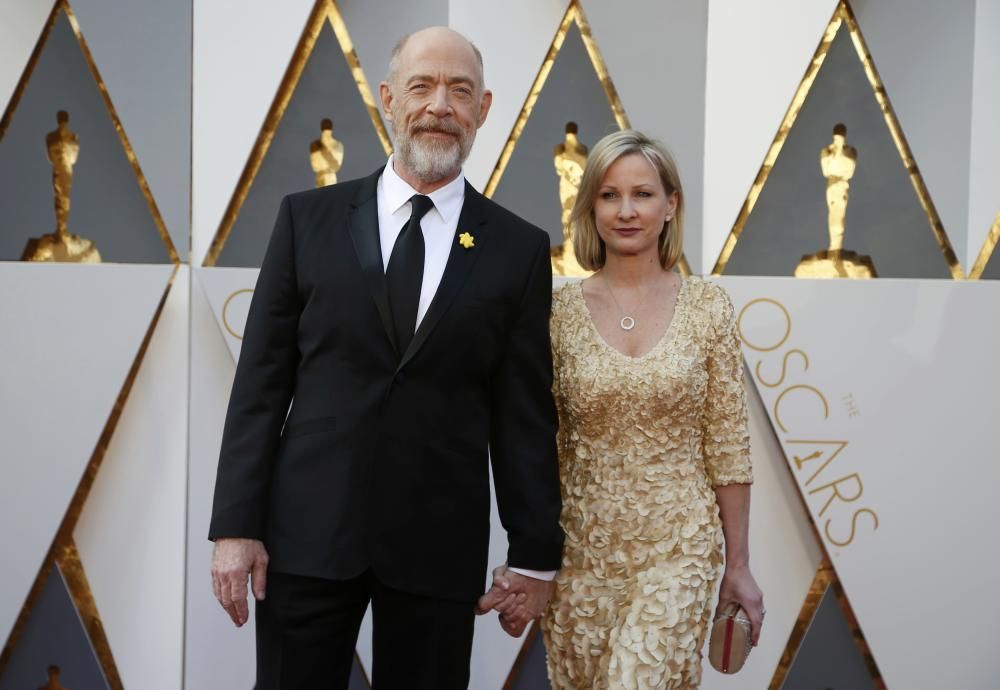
[{"x1": 702, "y1": 285, "x2": 753, "y2": 487}]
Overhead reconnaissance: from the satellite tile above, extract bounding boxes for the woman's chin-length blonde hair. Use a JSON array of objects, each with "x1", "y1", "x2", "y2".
[{"x1": 570, "y1": 129, "x2": 684, "y2": 271}]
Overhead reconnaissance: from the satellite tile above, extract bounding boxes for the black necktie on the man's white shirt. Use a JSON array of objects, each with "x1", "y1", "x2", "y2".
[{"x1": 385, "y1": 194, "x2": 434, "y2": 356}]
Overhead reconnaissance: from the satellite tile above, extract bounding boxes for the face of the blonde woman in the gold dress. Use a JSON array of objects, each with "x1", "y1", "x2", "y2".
[{"x1": 594, "y1": 153, "x2": 677, "y2": 260}]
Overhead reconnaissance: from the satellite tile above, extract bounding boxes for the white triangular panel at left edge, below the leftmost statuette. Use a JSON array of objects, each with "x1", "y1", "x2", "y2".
[{"x1": 0, "y1": 263, "x2": 174, "y2": 639}]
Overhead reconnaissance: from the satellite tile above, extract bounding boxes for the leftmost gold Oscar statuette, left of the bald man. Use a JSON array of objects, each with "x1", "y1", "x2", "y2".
[{"x1": 21, "y1": 110, "x2": 101, "y2": 264}]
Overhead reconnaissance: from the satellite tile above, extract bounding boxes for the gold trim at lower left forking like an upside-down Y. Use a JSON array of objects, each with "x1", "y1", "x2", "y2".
[{"x1": 0, "y1": 264, "x2": 179, "y2": 690}]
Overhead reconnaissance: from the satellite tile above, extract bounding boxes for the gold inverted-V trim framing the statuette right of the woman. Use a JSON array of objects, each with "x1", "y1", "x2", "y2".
[{"x1": 712, "y1": 0, "x2": 965, "y2": 280}]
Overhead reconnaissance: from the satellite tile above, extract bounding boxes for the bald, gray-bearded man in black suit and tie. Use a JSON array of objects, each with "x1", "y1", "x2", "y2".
[{"x1": 210, "y1": 27, "x2": 563, "y2": 690}]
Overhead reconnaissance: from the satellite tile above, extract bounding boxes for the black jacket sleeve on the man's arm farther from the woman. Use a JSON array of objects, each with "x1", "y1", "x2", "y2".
[{"x1": 209, "y1": 197, "x2": 301, "y2": 540}]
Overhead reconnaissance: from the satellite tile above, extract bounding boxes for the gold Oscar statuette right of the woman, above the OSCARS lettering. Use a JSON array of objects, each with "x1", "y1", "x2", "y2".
[{"x1": 795, "y1": 123, "x2": 876, "y2": 278}]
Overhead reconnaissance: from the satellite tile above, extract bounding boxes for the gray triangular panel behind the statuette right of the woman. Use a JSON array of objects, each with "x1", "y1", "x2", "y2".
[{"x1": 725, "y1": 24, "x2": 951, "y2": 278}]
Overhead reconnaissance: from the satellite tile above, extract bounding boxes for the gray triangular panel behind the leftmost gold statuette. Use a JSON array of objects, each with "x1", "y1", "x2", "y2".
[{"x1": 0, "y1": 12, "x2": 170, "y2": 264}]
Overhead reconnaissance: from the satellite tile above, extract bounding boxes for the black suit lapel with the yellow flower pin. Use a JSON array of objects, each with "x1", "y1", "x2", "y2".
[{"x1": 397, "y1": 182, "x2": 488, "y2": 371}]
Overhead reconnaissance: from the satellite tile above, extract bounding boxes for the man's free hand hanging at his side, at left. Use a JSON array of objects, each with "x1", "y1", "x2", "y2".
[{"x1": 212, "y1": 539, "x2": 267, "y2": 628}]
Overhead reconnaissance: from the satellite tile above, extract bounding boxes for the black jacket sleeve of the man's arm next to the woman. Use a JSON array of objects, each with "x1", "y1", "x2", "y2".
[{"x1": 490, "y1": 235, "x2": 563, "y2": 571}]
